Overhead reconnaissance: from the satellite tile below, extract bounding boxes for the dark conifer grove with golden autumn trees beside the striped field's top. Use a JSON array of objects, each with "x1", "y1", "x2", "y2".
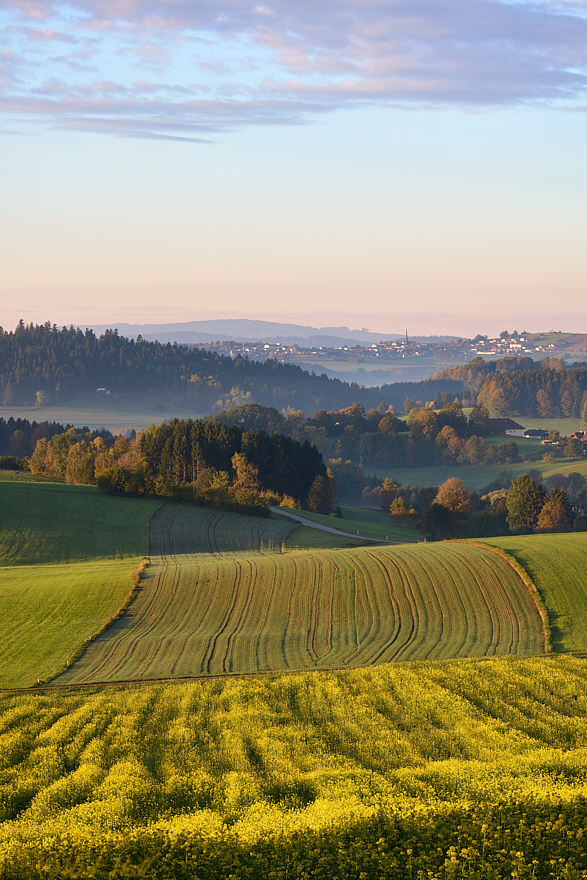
[{"x1": 29, "y1": 419, "x2": 335, "y2": 515}]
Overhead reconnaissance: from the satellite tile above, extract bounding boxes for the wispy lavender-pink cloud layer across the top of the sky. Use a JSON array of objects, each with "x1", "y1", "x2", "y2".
[{"x1": 0, "y1": 0, "x2": 587, "y2": 138}]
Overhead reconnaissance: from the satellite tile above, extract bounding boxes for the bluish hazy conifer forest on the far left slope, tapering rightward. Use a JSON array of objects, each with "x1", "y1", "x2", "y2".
[{"x1": 0, "y1": 321, "x2": 463, "y2": 413}]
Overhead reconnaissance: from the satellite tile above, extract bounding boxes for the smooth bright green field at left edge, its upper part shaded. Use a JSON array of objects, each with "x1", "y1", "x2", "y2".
[{"x1": 0, "y1": 480, "x2": 159, "y2": 687}]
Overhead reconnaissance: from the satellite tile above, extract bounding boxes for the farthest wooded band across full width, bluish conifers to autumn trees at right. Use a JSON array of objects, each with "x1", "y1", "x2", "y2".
[{"x1": 0, "y1": 321, "x2": 587, "y2": 418}]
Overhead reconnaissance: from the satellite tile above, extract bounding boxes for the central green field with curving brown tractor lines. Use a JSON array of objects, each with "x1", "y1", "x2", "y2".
[{"x1": 56, "y1": 504, "x2": 544, "y2": 684}]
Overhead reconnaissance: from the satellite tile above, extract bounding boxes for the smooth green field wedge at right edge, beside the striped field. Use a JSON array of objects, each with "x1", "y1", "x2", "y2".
[{"x1": 483, "y1": 533, "x2": 587, "y2": 652}]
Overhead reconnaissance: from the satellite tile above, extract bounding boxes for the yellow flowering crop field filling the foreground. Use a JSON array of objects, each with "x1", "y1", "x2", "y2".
[{"x1": 0, "y1": 657, "x2": 587, "y2": 880}]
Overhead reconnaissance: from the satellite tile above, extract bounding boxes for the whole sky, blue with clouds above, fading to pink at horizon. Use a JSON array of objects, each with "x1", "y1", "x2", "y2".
[{"x1": 0, "y1": 0, "x2": 587, "y2": 335}]
